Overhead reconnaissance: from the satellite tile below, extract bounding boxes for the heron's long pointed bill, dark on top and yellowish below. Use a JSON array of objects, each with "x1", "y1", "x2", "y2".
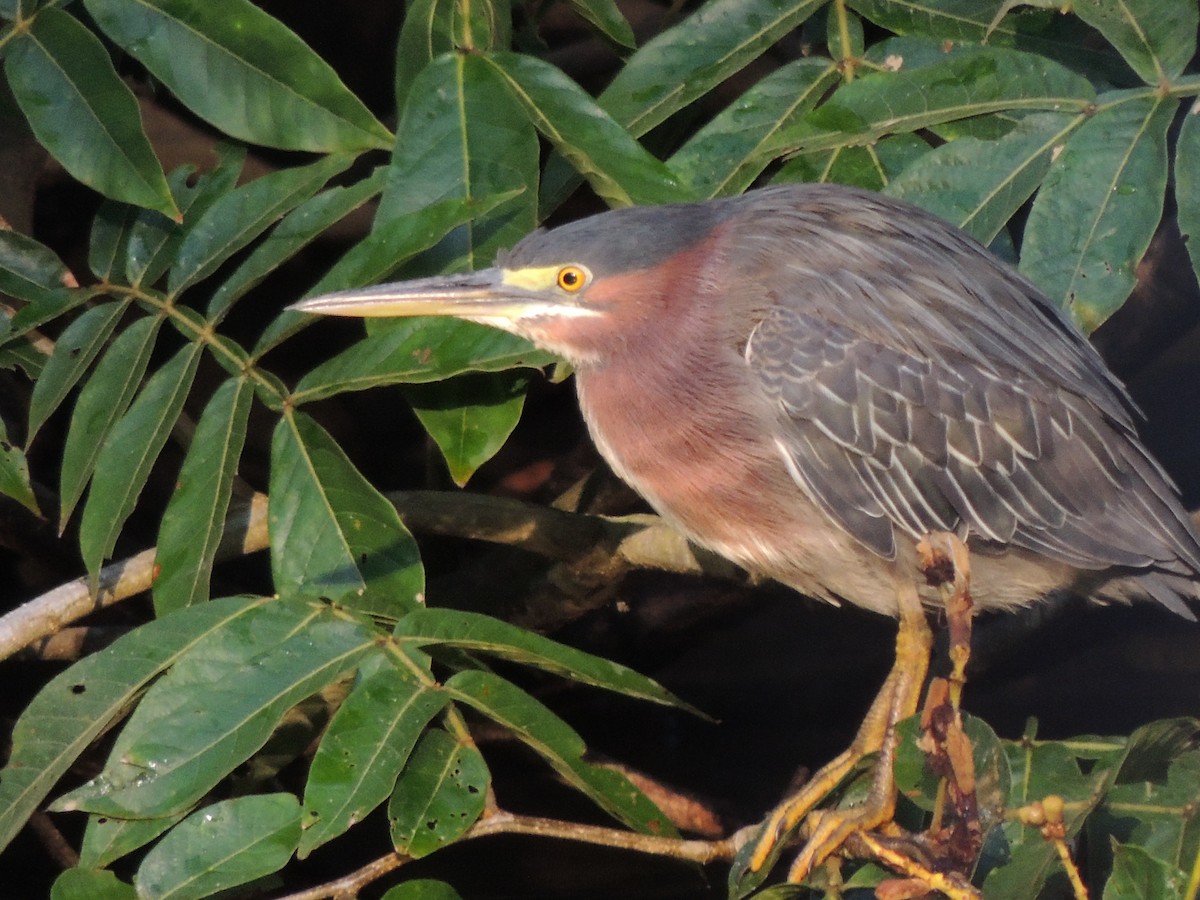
[{"x1": 289, "y1": 268, "x2": 595, "y2": 328}]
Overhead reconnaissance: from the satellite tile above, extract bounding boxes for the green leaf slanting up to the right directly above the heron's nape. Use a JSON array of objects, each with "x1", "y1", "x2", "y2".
[{"x1": 670, "y1": 59, "x2": 838, "y2": 197}]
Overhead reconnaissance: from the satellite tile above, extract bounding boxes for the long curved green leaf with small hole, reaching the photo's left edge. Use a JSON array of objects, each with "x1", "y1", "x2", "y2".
[{"x1": 0, "y1": 598, "x2": 267, "y2": 847}]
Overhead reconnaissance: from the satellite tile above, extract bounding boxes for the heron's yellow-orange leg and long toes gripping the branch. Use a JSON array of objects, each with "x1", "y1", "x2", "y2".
[{"x1": 750, "y1": 583, "x2": 932, "y2": 882}]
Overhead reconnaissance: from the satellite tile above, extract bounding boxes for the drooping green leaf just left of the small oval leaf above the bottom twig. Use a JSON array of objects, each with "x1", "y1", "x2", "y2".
[{"x1": 300, "y1": 665, "x2": 450, "y2": 858}]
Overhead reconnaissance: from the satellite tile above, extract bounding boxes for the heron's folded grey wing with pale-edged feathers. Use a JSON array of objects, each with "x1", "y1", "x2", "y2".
[{"x1": 745, "y1": 305, "x2": 1198, "y2": 585}]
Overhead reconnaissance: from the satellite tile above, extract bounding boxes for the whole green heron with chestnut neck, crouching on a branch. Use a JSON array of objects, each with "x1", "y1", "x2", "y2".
[{"x1": 295, "y1": 185, "x2": 1200, "y2": 880}]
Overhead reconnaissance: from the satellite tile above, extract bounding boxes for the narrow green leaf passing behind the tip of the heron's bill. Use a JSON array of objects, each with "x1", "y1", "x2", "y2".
[{"x1": 254, "y1": 192, "x2": 516, "y2": 355}]
